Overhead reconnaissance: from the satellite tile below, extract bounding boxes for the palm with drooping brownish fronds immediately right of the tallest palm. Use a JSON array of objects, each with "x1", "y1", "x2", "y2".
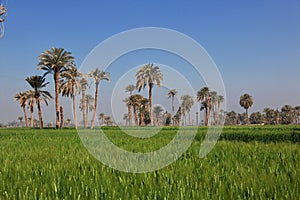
[{"x1": 59, "y1": 66, "x2": 82, "y2": 128}]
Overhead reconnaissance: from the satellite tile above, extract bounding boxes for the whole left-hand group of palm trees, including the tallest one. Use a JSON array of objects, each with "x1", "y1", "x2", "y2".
[{"x1": 15, "y1": 48, "x2": 110, "y2": 128}]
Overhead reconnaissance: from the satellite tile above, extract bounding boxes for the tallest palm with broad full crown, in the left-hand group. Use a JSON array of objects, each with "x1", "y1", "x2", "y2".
[{"x1": 38, "y1": 47, "x2": 74, "y2": 128}]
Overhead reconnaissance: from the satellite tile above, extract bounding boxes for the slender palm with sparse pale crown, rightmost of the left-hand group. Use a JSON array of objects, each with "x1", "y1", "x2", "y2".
[{"x1": 88, "y1": 68, "x2": 110, "y2": 128}]
